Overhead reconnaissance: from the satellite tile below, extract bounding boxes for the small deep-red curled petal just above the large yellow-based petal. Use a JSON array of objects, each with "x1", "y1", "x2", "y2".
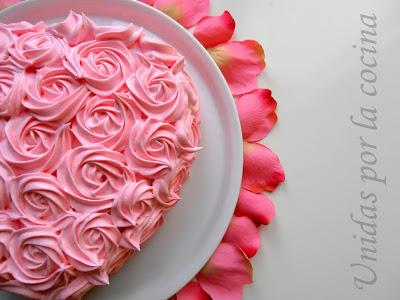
[{"x1": 193, "y1": 11, "x2": 236, "y2": 48}]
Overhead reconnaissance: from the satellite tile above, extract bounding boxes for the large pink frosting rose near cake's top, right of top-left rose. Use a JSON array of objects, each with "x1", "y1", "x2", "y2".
[{"x1": 64, "y1": 40, "x2": 134, "y2": 96}]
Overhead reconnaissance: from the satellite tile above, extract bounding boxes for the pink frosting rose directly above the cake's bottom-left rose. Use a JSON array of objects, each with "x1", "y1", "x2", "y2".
[{"x1": 10, "y1": 172, "x2": 72, "y2": 228}]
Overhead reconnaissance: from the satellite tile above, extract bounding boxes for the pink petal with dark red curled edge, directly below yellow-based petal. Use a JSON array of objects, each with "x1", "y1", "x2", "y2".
[{"x1": 236, "y1": 89, "x2": 278, "y2": 142}]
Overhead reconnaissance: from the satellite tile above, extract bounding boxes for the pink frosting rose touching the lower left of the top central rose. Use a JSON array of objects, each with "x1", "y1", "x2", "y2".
[{"x1": 22, "y1": 68, "x2": 90, "y2": 122}]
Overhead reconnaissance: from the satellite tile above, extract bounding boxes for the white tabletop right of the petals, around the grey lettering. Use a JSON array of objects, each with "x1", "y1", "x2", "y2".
[{"x1": 211, "y1": 0, "x2": 400, "y2": 300}]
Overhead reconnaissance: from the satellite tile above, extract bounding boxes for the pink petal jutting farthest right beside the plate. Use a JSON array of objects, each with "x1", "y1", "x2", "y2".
[{"x1": 242, "y1": 142, "x2": 285, "y2": 193}]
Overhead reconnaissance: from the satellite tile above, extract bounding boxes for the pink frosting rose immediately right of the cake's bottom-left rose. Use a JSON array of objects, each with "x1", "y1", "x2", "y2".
[{"x1": 60, "y1": 213, "x2": 121, "y2": 284}]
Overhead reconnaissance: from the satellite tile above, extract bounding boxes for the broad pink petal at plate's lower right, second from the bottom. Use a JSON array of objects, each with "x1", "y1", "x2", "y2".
[{"x1": 197, "y1": 243, "x2": 253, "y2": 300}]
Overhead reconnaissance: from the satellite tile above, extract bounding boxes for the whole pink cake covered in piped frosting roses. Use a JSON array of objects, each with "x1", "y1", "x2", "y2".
[{"x1": 0, "y1": 13, "x2": 200, "y2": 299}]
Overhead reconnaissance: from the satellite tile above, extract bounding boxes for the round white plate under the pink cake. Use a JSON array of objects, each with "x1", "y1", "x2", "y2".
[{"x1": 0, "y1": 0, "x2": 243, "y2": 300}]
